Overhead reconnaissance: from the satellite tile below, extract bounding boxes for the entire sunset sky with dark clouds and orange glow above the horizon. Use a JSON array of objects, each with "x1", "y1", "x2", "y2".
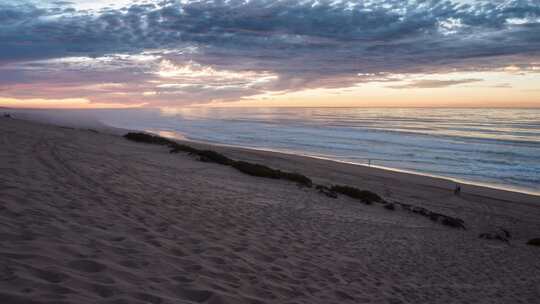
[{"x1": 0, "y1": 0, "x2": 540, "y2": 108}]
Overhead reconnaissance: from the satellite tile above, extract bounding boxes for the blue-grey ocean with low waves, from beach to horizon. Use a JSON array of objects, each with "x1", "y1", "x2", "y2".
[{"x1": 92, "y1": 108, "x2": 540, "y2": 193}]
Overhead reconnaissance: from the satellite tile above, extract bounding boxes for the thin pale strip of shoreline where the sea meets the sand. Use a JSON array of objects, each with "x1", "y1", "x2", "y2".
[{"x1": 148, "y1": 130, "x2": 540, "y2": 199}]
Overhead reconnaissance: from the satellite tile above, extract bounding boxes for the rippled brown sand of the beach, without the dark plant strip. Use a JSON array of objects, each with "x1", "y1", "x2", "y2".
[{"x1": 0, "y1": 118, "x2": 540, "y2": 304}]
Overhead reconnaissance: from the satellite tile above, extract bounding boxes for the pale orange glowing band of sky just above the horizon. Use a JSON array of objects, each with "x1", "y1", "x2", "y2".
[{"x1": 0, "y1": 71, "x2": 540, "y2": 108}]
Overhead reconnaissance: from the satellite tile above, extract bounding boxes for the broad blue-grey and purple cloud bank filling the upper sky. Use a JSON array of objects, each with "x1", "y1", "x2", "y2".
[{"x1": 0, "y1": 0, "x2": 540, "y2": 105}]
